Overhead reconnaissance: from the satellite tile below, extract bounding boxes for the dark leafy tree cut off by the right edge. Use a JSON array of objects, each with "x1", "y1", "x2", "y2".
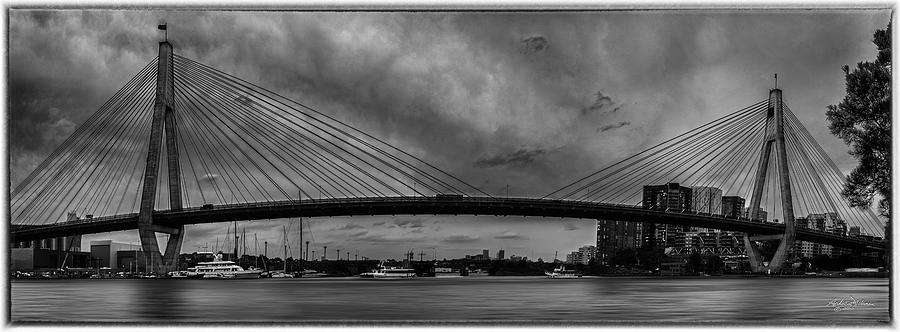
[{"x1": 826, "y1": 24, "x2": 891, "y2": 216}]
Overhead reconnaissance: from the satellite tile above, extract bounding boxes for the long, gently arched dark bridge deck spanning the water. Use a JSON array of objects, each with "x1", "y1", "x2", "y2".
[{"x1": 12, "y1": 196, "x2": 886, "y2": 251}]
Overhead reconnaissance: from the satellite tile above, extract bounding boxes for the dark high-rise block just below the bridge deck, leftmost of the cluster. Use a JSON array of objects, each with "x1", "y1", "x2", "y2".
[{"x1": 596, "y1": 220, "x2": 644, "y2": 265}]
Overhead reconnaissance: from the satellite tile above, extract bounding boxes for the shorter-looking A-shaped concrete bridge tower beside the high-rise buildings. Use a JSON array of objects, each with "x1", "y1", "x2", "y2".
[{"x1": 744, "y1": 88, "x2": 797, "y2": 272}]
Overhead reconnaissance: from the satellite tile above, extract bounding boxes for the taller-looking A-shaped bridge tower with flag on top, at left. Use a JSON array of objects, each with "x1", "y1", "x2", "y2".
[{"x1": 138, "y1": 41, "x2": 184, "y2": 273}]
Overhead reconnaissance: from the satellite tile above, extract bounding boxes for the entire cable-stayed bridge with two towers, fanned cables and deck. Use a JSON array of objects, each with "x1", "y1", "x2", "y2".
[{"x1": 10, "y1": 42, "x2": 886, "y2": 271}]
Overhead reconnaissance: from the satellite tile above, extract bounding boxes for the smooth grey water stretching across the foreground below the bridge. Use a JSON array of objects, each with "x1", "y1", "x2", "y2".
[{"x1": 11, "y1": 277, "x2": 889, "y2": 324}]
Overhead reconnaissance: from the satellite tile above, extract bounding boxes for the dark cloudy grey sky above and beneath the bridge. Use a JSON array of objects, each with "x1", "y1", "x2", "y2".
[{"x1": 8, "y1": 10, "x2": 890, "y2": 259}]
